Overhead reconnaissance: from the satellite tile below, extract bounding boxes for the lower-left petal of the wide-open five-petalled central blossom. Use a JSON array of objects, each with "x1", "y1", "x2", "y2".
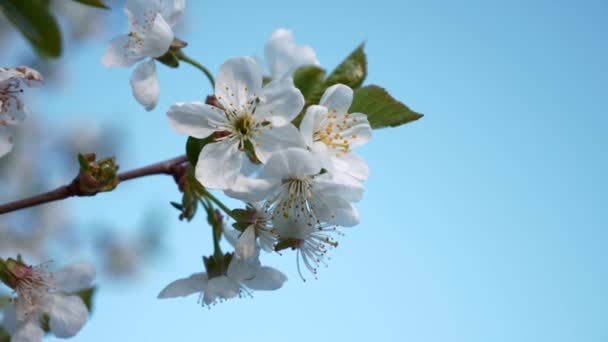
[{"x1": 195, "y1": 139, "x2": 244, "y2": 189}]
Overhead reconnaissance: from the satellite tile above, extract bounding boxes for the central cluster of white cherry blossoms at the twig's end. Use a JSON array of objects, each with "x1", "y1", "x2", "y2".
[{"x1": 159, "y1": 29, "x2": 372, "y2": 305}]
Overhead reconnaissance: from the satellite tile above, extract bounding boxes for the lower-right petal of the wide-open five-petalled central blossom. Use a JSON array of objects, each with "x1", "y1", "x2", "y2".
[{"x1": 252, "y1": 123, "x2": 306, "y2": 163}]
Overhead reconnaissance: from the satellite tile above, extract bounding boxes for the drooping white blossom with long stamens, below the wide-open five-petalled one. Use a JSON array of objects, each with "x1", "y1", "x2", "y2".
[{"x1": 226, "y1": 148, "x2": 363, "y2": 279}]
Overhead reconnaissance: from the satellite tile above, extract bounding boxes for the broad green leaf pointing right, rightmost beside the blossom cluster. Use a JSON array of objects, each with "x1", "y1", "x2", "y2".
[{"x1": 350, "y1": 85, "x2": 423, "y2": 129}]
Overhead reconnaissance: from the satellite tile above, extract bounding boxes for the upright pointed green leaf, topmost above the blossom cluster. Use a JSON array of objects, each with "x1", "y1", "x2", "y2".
[{"x1": 323, "y1": 43, "x2": 367, "y2": 91}]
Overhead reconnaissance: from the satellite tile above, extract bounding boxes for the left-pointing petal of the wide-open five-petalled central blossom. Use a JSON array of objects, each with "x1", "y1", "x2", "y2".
[{"x1": 167, "y1": 102, "x2": 227, "y2": 139}]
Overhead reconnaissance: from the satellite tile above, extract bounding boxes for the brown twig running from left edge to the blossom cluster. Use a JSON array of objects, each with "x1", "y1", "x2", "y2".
[{"x1": 0, "y1": 155, "x2": 188, "y2": 215}]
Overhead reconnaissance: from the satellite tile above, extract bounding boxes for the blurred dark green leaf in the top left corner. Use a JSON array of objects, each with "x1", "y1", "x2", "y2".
[{"x1": 0, "y1": 0, "x2": 61, "y2": 58}]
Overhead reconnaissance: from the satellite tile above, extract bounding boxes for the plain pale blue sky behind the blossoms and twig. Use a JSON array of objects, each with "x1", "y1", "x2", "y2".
[{"x1": 8, "y1": 0, "x2": 608, "y2": 342}]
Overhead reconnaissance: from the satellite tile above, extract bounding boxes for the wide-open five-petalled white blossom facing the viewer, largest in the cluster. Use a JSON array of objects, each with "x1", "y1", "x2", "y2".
[{"x1": 167, "y1": 57, "x2": 304, "y2": 189}]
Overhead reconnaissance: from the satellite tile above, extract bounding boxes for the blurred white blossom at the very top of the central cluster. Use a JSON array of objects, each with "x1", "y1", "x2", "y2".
[{"x1": 264, "y1": 28, "x2": 320, "y2": 80}]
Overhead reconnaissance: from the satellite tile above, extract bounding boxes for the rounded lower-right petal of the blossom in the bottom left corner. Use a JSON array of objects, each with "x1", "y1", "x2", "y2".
[{"x1": 49, "y1": 295, "x2": 89, "y2": 338}]
